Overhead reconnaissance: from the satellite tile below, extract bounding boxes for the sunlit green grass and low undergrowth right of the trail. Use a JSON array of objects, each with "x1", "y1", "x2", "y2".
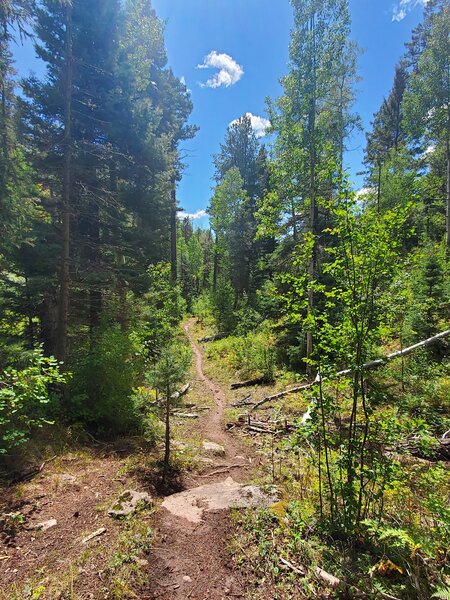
[{"x1": 200, "y1": 314, "x2": 450, "y2": 600}]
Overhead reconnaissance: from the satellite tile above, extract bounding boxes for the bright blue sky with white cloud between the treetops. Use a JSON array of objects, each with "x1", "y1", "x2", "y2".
[{"x1": 15, "y1": 0, "x2": 426, "y2": 224}]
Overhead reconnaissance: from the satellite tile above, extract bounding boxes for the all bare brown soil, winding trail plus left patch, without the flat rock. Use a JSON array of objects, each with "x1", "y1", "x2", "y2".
[{"x1": 0, "y1": 324, "x2": 266, "y2": 600}]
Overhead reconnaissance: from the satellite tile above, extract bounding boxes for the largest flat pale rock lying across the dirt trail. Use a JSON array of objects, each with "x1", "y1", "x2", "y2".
[{"x1": 162, "y1": 477, "x2": 278, "y2": 523}]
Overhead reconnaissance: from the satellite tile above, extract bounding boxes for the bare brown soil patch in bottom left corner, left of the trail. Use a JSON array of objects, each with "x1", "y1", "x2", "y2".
[{"x1": 0, "y1": 453, "x2": 144, "y2": 600}]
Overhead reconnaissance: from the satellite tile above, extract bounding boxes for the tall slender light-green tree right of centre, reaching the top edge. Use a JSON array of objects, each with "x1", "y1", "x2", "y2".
[{"x1": 271, "y1": 0, "x2": 357, "y2": 370}]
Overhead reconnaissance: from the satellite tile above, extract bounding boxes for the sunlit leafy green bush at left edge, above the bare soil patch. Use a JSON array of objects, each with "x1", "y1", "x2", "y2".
[{"x1": 0, "y1": 349, "x2": 69, "y2": 454}]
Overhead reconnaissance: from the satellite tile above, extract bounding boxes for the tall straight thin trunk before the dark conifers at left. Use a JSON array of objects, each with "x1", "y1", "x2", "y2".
[{"x1": 56, "y1": 4, "x2": 73, "y2": 362}]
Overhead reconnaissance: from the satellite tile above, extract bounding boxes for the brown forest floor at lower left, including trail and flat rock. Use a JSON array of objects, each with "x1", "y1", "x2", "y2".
[{"x1": 0, "y1": 321, "x2": 273, "y2": 600}]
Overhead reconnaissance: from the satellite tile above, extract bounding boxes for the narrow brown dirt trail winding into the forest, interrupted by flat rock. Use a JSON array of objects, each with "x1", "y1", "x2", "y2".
[{"x1": 149, "y1": 323, "x2": 255, "y2": 600}]
